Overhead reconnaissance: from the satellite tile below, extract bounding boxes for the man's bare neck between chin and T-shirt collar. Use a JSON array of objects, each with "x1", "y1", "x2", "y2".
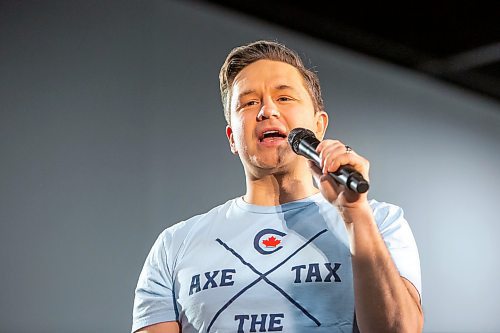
[{"x1": 244, "y1": 161, "x2": 319, "y2": 206}]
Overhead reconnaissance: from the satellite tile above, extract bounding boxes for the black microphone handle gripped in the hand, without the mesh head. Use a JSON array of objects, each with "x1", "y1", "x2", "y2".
[{"x1": 299, "y1": 139, "x2": 370, "y2": 193}]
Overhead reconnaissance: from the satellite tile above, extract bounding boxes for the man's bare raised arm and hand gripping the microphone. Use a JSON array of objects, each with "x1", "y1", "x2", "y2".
[{"x1": 310, "y1": 140, "x2": 423, "y2": 333}]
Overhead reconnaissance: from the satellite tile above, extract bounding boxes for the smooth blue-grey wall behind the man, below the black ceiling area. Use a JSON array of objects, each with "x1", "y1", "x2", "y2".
[{"x1": 0, "y1": 1, "x2": 500, "y2": 332}]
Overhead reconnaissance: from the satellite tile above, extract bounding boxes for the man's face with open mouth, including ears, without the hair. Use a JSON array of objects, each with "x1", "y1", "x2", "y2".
[{"x1": 226, "y1": 60, "x2": 328, "y2": 174}]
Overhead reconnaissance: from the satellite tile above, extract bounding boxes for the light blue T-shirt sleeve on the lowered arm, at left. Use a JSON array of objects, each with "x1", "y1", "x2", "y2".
[{"x1": 132, "y1": 230, "x2": 177, "y2": 332}]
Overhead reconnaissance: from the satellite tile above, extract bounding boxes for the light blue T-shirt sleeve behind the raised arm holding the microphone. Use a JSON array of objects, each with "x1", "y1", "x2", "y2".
[{"x1": 371, "y1": 202, "x2": 422, "y2": 299}]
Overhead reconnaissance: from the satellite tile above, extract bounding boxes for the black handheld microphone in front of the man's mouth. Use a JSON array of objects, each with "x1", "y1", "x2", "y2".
[{"x1": 288, "y1": 127, "x2": 370, "y2": 193}]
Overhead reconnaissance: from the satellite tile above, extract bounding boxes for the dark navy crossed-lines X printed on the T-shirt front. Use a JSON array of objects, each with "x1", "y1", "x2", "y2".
[{"x1": 207, "y1": 229, "x2": 327, "y2": 333}]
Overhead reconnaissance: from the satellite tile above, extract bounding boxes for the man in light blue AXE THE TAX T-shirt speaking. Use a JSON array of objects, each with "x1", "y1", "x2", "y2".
[{"x1": 132, "y1": 41, "x2": 423, "y2": 333}]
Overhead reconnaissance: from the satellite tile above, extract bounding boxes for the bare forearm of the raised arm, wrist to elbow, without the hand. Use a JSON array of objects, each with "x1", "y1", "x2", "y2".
[{"x1": 342, "y1": 204, "x2": 423, "y2": 333}]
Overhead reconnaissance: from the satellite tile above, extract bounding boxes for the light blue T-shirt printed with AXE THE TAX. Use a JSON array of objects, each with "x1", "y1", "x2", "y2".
[{"x1": 132, "y1": 193, "x2": 421, "y2": 333}]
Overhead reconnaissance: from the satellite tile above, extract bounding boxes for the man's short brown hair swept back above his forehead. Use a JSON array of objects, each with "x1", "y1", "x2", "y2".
[{"x1": 219, "y1": 40, "x2": 324, "y2": 124}]
